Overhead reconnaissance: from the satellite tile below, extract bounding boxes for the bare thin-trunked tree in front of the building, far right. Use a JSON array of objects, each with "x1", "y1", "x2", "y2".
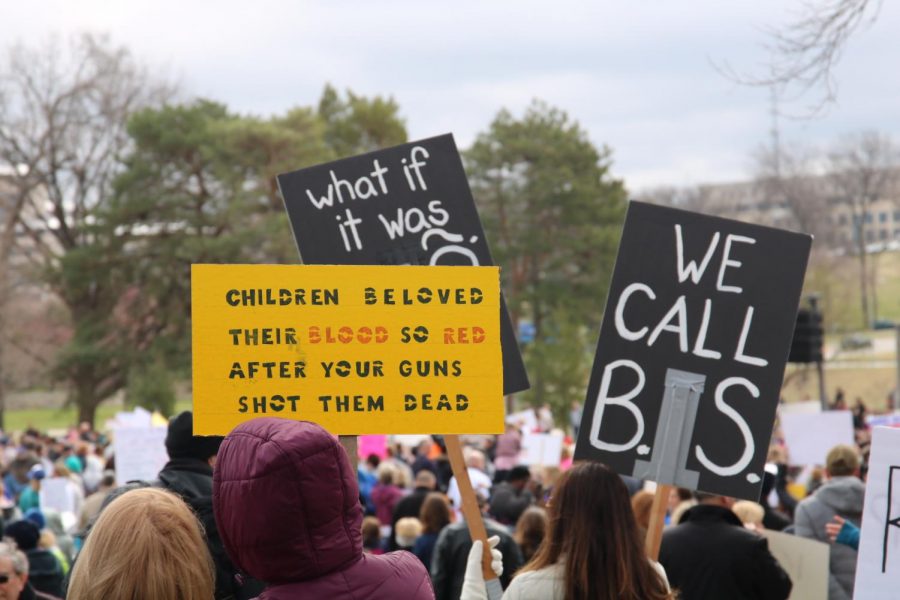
[{"x1": 828, "y1": 131, "x2": 898, "y2": 328}]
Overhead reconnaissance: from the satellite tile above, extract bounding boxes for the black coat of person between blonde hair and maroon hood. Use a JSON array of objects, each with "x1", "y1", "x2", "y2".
[{"x1": 158, "y1": 458, "x2": 263, "y2": 600}]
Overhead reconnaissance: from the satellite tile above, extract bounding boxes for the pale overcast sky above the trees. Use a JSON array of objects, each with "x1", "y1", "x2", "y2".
[{"x1": 0, "y1": 0, "x2": 900, "y2": 190}]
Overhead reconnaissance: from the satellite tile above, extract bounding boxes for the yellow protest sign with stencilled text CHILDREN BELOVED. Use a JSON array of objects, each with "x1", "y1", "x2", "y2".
[{"x1": 191, "y1": 265, "x2": 504, "y2": 435}]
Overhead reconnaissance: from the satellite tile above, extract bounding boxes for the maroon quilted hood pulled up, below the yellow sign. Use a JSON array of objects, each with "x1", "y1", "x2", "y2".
[{"x1": 213, "y1": 418, "x2": 362, "y2": 584}]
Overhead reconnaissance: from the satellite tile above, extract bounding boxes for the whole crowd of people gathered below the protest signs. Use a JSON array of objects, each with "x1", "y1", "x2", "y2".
[{"x1": 0, "y1": 396, "x2": 880, "y2": 600}]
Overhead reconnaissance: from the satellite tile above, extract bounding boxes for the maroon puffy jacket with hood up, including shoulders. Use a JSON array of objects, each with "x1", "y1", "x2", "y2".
[{"x1": 213, "y1": 418, "x2": 434, "y2": 600}]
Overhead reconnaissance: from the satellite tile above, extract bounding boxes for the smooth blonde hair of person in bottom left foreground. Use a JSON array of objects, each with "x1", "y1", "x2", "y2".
[{"x1": 66, "y1": 488, "x2": 214, "y2": 600}]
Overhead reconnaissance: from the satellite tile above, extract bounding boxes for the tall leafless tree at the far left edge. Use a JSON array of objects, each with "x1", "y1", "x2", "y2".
[{"x1": 0, "y1": 34, "x2": 172, "y2": 422}]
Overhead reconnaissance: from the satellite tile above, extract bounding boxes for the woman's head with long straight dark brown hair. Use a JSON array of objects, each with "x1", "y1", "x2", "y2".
[{"x1": 524, "y1": 462, "x2": 670, "y2": 600}]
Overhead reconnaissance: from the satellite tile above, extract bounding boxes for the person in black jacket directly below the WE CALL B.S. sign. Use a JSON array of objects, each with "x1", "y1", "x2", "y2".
[{"x1": 659, "y1": 493, "x2": 791, "y2": 600}]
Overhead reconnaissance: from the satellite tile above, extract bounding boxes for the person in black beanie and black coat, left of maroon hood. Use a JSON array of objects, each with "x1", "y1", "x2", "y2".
[{"x1": 158, "y1": 411, "x2": 262, "y2": 599}]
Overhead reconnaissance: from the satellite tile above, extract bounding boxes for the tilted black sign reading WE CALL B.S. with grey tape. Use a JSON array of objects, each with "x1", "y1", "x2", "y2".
[{"x1": 575, "y1": 202, "x2": 812, "y2": 500}]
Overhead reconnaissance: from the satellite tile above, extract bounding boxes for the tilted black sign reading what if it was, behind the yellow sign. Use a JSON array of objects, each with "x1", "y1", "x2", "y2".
[{"x1": 278, "y1": 134, "x2": 529, "y2": 394}]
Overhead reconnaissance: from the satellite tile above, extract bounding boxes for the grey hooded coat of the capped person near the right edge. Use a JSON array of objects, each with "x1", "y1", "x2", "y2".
[{"x1": 794, "y1": 477, "x2": 866, "y2": 600}]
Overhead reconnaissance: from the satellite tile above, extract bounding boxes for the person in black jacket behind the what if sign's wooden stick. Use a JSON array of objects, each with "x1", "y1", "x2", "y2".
[{"x1": 431, "y1": 492, "x2": 522, "y2": 600}]
